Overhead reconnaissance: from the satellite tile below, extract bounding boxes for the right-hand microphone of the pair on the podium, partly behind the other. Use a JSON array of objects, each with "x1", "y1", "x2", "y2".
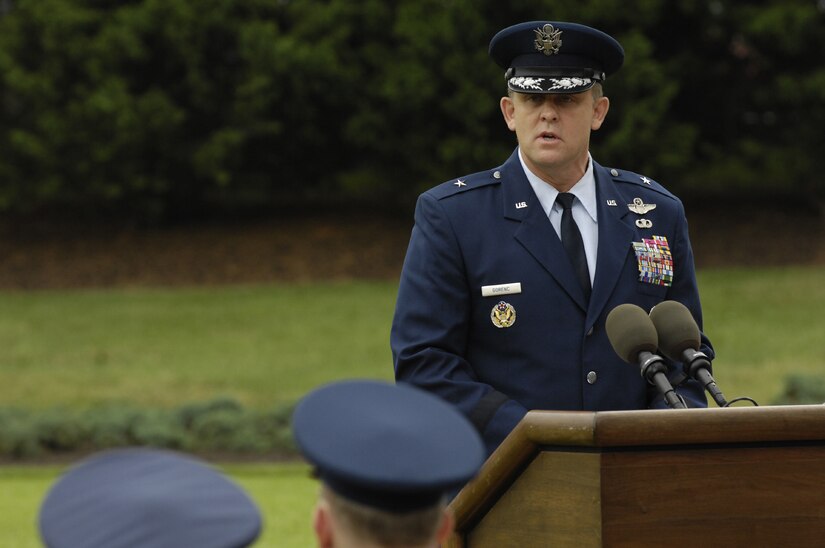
[{"x1": 650, "y1": 301, "x2": 728, "y2": 407}]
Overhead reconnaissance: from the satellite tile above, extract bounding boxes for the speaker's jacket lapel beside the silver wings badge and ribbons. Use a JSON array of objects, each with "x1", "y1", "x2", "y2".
[{"x1": 586, "y1": 166, "x2": 634, "y2": 329}]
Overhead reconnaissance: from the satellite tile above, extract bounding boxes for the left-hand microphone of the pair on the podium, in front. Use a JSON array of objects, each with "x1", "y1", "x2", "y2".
[{"x1": 605, "y1": 304, "x2": 687, "y2": 409}]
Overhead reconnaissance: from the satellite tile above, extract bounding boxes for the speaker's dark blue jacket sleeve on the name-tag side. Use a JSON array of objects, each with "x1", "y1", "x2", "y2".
[{"x1": 390, "y1": 194, "x2": 527, "y2": 453}]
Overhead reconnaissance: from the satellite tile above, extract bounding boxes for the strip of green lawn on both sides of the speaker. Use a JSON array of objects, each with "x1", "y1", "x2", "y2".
[{"x1": 0, "y1": 267, "x2": 825, "y2": 409}]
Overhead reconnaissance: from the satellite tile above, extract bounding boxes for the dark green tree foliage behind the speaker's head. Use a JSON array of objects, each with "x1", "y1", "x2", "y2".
[{"x1": 0, "y1": 0, "x2": 825, "y2": 220}]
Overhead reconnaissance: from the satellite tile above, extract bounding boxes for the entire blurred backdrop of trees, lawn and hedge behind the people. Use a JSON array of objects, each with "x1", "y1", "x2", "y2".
[{"x1": 0, "y1": 0, "x2": 825, "y2": 546}]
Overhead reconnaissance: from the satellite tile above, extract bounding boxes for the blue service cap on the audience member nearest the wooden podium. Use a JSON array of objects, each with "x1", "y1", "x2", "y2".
[{"x1": 292, "y1": 380, "x2": 485, "y2": 513}]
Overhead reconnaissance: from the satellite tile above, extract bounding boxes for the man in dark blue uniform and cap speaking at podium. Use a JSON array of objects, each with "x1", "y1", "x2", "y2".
[{"x1": 391, "y1": 21, "x2": 714, "y2": 453}]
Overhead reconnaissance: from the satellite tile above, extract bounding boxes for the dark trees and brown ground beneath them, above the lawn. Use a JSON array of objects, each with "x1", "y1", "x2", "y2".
[{"x1": 0, "y1": 0, "x2": 825, "y2": 288}]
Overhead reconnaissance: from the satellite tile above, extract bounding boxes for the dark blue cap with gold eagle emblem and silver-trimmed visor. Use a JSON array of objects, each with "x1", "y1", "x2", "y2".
[{"x1": 490, "y1": 21, "x2": 624, "y2": 93}]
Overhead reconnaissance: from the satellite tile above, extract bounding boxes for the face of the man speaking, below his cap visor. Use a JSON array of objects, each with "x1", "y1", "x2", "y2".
[{"x1": 501, "y1": 90, "x2": 609, "y2": 185}]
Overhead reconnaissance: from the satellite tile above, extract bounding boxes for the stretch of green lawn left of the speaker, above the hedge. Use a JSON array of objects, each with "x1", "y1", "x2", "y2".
[{"x1": 0, "y1": 282, "x2": 397, "y2": 408}]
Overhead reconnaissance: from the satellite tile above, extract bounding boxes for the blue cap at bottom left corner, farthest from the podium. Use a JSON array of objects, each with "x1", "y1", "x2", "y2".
[{"x1": 39, "y1": 448, "x2": 261, "y2": 548}]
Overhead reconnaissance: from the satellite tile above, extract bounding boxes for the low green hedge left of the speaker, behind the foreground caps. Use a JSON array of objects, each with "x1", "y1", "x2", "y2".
[{"x1": 0, "y1": 398, "x2": 296, "y2": 460}]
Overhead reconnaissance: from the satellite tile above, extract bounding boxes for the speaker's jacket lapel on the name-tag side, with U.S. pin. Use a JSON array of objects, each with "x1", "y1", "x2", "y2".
[{"x1": 501, "y1": 152, "x2": 587, "y2": 310}]
